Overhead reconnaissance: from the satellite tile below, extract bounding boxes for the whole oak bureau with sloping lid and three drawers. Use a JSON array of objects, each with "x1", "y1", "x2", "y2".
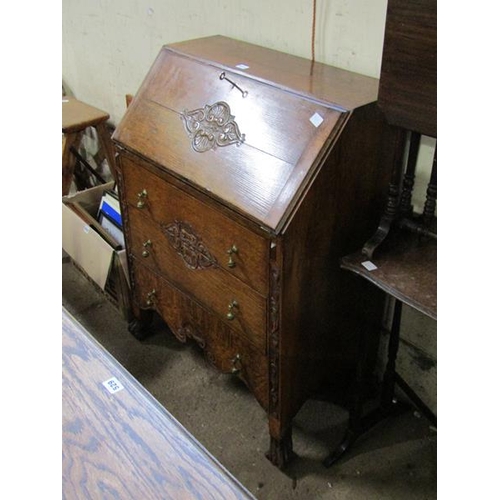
[{"x1": 113, "y1": 36, "x2": 390, "y2": 467}]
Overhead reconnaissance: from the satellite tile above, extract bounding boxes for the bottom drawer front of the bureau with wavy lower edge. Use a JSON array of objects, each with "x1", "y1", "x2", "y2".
[{"x1": 133, "y1": 263, "x2": 269, "y2": 409}]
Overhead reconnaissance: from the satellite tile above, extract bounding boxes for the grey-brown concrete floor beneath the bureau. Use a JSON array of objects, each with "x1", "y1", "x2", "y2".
[{"x1": 62, "y1": 258, "x2": 437, "y2": 500}]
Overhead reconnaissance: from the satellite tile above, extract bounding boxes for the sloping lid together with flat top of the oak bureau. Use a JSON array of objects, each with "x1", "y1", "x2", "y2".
[{"x1": 113, "y1": 37, "x2": 377, "y2": 231}]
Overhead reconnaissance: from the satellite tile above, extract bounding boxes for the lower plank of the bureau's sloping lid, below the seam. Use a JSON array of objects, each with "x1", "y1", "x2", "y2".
[{"x1": 113, "y1": 97, "x2": 293, "y2": 228}]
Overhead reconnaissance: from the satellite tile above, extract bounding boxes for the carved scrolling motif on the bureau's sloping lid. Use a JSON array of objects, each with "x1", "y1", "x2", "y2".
[{"x1": 181, "y1": 101, "x2": 245, "y2": 153}]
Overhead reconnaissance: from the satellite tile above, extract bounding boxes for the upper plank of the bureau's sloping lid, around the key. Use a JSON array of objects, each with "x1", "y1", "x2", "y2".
[{"x1": 141, "y1": 48, "x2": 339, "y2": 164}]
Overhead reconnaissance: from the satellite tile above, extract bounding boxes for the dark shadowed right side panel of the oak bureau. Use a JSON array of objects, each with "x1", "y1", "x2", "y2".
[{"x1": 280, "y1": 104, "x2": 390, "y2": 418}]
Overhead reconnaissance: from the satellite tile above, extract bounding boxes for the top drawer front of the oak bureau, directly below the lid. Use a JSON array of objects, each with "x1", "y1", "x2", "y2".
[{"x1": 122, "y1": 158, "x2": 269, "y2": 295}]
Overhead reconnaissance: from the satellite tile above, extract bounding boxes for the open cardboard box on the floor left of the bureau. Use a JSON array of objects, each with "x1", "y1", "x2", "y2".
[{"x1": 62, "y1": 182, "x2": 130, "y2": 319}]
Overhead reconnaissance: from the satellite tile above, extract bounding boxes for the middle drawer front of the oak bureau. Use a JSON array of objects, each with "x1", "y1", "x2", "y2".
[{"x1": 134, "y1": 250, "x2": 267, "y2": 352}]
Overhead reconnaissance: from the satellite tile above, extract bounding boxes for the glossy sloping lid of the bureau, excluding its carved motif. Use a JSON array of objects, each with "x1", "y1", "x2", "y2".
[{"x1": 113, "y1": 42, "x2": 344, "y2": 230}]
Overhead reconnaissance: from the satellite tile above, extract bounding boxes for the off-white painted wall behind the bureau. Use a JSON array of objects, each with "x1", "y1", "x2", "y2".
[{"x1": 62, "y1": 0, "x2": 436, "y2": 407}]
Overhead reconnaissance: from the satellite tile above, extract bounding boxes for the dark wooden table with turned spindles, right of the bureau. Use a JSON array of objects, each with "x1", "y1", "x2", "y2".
[{"x1": 324, "y1": 0, "x2": 437, "y2": 467}]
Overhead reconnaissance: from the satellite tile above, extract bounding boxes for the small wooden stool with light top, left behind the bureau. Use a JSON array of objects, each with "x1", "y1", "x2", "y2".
[{"x1": 62, "y1": 97, "x2": 115, "y2": 196}]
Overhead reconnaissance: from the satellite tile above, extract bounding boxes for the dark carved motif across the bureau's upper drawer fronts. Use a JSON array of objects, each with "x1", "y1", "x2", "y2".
[{"x1": 161, "y1": 221, "x2": 217, "y2": 269}]
